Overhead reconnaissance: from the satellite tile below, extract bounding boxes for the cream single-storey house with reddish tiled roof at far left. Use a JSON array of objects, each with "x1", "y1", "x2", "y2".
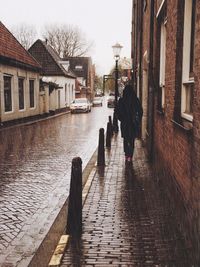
[{"x1": 0, "y1": 22, "x2": 41, "y2": 122}]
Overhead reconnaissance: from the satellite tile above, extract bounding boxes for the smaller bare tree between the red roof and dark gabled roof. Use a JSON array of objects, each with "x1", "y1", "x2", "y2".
[{"x1": 11, "y1": 23, "x2": 37, "y2": 50}]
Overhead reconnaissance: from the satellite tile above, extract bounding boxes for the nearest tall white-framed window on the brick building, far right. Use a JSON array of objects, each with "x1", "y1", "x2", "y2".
[{"x1": 181, "y1": 0, "x2": 195, "y2": 121}]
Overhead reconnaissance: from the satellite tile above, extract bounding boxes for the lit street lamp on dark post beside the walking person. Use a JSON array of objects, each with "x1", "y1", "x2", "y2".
[{"x1": 112, "y1": 43, "x2": 123, "y2": 133}]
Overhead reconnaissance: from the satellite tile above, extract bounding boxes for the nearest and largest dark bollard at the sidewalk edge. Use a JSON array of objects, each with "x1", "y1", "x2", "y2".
[{"x1": 66, "y1": 157, "x2": 82, "y2": 237}]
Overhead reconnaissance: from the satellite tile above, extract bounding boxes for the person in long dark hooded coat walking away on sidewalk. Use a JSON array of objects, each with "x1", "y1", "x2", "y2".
[{"x1": 117, "y1": 85, "x2": 143, "y2": 162}]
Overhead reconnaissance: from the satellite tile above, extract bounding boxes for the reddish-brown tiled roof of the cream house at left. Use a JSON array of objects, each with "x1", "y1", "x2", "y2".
[{"x1": 0, "y1": 21, "x2": 41, "y2": 68}]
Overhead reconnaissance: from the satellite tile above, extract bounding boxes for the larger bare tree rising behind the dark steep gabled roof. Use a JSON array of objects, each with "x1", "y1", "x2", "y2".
[{"x1": 43, "y1": 24, "x2": 92, "y2": 58}]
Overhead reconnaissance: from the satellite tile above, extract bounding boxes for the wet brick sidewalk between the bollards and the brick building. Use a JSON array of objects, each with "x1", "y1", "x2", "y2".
[{"x1": 61, "y1": 135, "x2": 191, "y2": 267}]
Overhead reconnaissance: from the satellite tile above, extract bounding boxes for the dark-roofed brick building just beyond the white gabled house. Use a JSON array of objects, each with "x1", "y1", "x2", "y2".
[{"x1": 64, "y1": 57, "x2": 95, "y2": 99}]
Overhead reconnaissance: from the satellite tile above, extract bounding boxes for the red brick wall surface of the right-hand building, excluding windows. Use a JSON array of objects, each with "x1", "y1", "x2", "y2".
[{"x1": 154, "y1": 0, "x2": 200, "y2": 264}]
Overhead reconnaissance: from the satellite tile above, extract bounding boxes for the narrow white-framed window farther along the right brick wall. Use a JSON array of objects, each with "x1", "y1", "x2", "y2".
[{"x1": 159, "y1": 18, "x2": 167, "y2": 109}]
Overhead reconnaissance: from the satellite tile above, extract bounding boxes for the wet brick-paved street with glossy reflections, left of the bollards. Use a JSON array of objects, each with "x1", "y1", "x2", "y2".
[{"x1": 0, "y1": 107, "x2": 113, "y2": 251}]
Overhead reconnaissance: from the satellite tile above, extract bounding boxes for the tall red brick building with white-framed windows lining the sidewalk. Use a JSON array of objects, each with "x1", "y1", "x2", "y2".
[{"x1": 132, "y1": 0, "x2": 200, "y2": 266}]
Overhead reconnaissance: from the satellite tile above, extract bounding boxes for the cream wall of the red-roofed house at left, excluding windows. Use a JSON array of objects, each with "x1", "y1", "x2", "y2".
[{"x1": 0, "y1": 64, "x2": 40, "y2": 122}]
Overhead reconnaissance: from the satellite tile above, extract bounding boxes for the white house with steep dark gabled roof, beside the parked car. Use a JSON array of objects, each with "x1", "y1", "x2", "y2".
[{"x1": 29, "y1": 40, "x2": 76, "y2": 111}]
